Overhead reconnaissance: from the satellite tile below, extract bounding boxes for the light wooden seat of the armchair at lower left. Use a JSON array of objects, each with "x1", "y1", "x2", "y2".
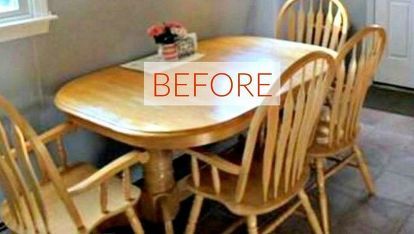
[{"x1": 0, "y1": 163, "x2": 140, "y2": 233}]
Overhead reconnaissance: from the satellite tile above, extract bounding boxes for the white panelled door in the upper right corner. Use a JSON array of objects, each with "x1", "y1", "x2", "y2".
[{"x1": 375, "y1": 0, "x2": 414, "y2": 88}]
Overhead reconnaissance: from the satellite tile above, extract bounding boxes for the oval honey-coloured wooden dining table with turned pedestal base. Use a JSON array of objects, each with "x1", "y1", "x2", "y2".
[{"x1": 55, "y1": 36, "x2": 336, "y2": 229}]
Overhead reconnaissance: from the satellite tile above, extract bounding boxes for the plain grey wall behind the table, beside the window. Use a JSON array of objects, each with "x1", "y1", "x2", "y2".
[{"x1": 0, "y1": 0, "x2": 251, "y2": 167}]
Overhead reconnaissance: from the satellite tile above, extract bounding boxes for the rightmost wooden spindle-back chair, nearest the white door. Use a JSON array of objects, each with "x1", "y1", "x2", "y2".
[{"x1": 310, "y1": 25, "x2": 386, "y2": 233}]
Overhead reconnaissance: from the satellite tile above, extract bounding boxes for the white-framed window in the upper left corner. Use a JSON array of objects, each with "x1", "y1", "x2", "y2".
[{"x1": 0, "y1": 0, "x2": 57, "y2": 42}]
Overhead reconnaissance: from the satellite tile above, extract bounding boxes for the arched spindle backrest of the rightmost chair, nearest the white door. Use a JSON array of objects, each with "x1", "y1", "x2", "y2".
[{"x1": 327, "y1": 25, "x2": 387, "y2": 147}]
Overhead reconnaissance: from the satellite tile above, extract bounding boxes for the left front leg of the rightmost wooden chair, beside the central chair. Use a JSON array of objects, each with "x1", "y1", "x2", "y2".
[{"x1": 316, "y1": 158, "x2": 330, "y2": 234}]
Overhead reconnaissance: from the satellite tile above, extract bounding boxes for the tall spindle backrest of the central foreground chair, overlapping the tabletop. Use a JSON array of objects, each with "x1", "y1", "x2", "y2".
[{"x1": 235, "y1": 52, "x2": 336, "y2": 202}]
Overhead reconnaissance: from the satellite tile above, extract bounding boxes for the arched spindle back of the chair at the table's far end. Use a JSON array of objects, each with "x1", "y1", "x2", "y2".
[{"x1": 276, "y1": 0, "x2": 349, "y2": 50}]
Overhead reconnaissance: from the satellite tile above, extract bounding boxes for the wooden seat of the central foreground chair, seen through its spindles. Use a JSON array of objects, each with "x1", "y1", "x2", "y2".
[{"x1": 187, "y1": 148, "x2": 309, "y2": 216}]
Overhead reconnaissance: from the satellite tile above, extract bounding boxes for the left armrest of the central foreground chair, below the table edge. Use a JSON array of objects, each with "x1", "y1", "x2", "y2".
[{"x1": 184, "y1": 149, "x2": 240, "y2": 175}]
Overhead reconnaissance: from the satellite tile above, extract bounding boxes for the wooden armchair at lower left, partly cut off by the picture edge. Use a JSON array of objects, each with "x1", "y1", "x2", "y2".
[{"x1": 0, "y1": 96, "x2": 148, "y2": 234}]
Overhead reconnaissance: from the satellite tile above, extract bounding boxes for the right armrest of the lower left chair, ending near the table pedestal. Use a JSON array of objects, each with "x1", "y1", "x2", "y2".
[{"x1": 68, "y1": 150, "x2": 149, "y2": 195}]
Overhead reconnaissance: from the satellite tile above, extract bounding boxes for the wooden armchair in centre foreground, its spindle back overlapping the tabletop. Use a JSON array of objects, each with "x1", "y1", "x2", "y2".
[{"x1": 186, "y1": 52, "x2": 335, "y2": 234}]
